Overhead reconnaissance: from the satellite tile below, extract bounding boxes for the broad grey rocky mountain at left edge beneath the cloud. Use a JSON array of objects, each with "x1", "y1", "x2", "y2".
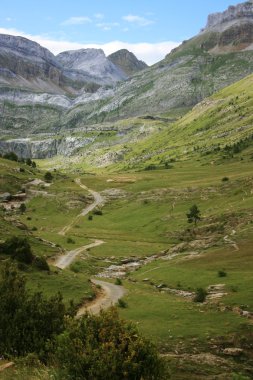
[{"x1": 0, "y1": 34, "x2": 83, "y2": 93}]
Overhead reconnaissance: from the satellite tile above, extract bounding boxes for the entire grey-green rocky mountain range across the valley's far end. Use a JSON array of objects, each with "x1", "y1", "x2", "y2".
[{"x1": 0, "y1": 2, "x2": 253, "y2": 157}]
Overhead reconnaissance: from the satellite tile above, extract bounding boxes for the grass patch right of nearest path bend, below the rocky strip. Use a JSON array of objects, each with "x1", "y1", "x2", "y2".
[{"x1": 120, "y1": 282, "x2": 245, "y2": 350}]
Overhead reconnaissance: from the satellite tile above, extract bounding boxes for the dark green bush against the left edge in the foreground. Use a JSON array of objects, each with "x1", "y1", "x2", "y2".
[{"x1": 0, "y1": 264, "x2": 66, "y2": 360}]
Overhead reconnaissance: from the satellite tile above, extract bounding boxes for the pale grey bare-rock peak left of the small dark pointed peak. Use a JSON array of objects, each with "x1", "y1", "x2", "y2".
[{"x1": 57, "y1": 49, "x2": 127, "y2": 84}]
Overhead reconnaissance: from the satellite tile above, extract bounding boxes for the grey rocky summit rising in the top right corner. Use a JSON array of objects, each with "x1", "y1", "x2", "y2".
[{"x1": 204, "y1": 1, "x2": 253, "y2": 32}]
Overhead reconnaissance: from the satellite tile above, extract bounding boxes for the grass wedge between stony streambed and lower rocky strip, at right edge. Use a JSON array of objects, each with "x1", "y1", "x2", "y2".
[{"x1": 131, "y1": 240, "x2": 253, "y2": 311}]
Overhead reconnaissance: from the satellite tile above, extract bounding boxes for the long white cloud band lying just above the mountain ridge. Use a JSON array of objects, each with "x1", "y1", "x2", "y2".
[{"x1": 0, "y1": 28, "x2": 179, "y2": 65}]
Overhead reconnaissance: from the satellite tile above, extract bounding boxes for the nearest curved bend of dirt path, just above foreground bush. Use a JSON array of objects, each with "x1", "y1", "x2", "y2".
[{"x1": 77, "y1": 279, "x2": 126, "y2": 317}]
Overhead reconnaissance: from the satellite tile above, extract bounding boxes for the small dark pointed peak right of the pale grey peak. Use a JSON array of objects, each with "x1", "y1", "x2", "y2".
[{"x1": 108, "y1": 49, "x2": 148, "y2": 76}]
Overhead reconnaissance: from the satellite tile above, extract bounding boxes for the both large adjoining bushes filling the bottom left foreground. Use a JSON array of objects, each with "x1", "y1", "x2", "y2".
[{"x1": 0, "y1": 265, "x2": 168, "y2": 380}]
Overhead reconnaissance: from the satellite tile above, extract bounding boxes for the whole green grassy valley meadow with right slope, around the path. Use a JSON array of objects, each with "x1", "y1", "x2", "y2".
[{"x1": 0, "y1": 77, "x2": 253, "y2": 380}]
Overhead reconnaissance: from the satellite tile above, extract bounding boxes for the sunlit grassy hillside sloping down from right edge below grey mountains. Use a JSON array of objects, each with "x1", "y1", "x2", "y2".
[{"x1": 29, "y1": 70, "x2": 253, "y2": 171}]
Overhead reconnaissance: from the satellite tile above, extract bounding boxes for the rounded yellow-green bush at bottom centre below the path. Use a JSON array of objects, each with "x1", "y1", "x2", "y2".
[{"x1": 56, "y1": 309, "x2": 168, "y2": 380}]
